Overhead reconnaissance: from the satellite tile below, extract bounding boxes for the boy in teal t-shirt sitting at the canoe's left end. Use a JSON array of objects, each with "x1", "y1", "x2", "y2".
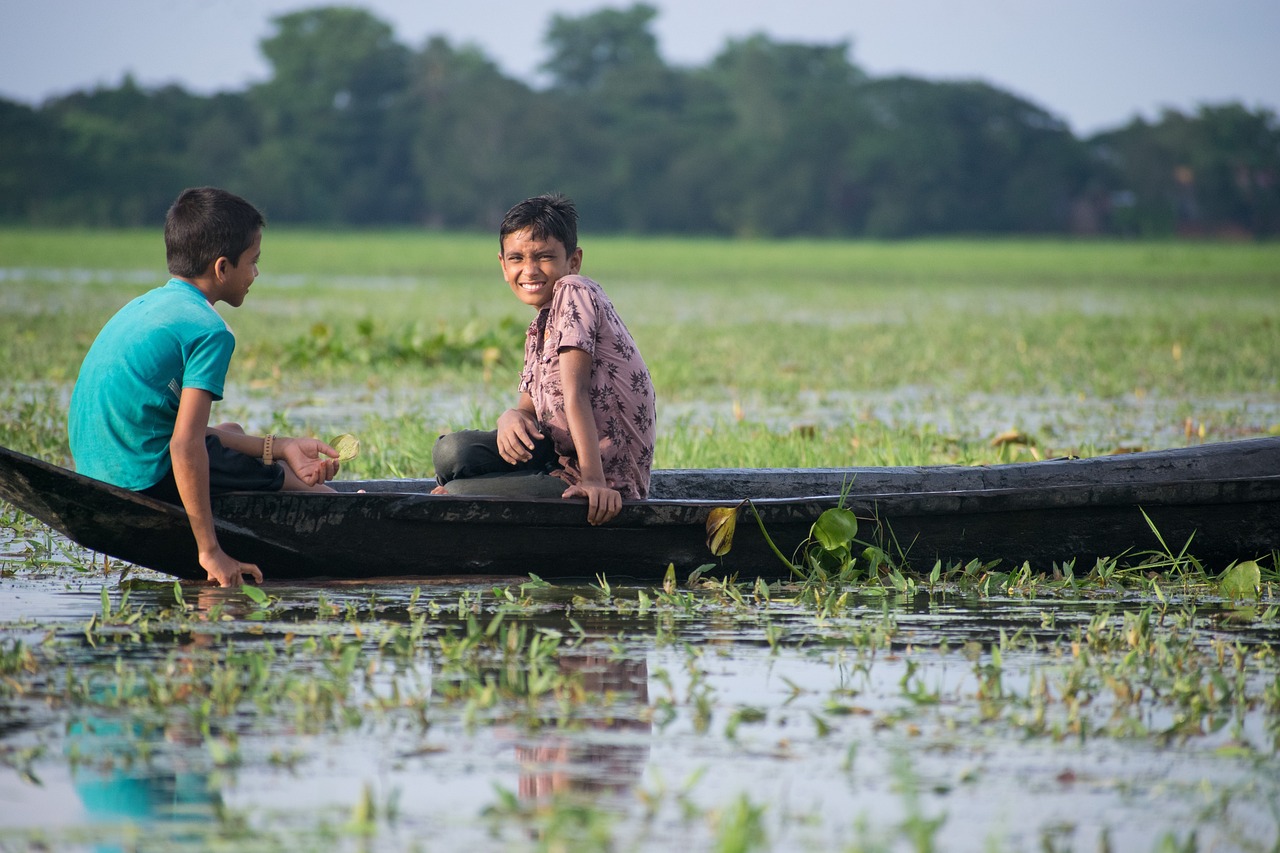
[{"x1": 68, "y1": 187, "x2": 338, "y2": 587}]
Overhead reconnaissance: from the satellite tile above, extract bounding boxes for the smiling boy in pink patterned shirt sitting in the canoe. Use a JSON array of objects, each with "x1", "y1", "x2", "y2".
[{"x1": 433, "y1": 193, "x2": 657, "y2": 524}]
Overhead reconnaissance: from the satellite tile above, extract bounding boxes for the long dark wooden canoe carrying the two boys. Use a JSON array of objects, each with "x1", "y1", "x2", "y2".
[{"x1": 0, "y1": 438, "x2": 1280, "y2": 580}]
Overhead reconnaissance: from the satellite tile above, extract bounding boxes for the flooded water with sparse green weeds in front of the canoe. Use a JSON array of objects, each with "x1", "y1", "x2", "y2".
[{"x1": 0, "y1": 517, "x2": 1280, "y2": 850}]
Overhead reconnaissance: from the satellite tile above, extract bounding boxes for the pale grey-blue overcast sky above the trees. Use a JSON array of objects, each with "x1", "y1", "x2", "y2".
[{"x1": 0, "y1": 0, "x2": 1280, "y2": 134}]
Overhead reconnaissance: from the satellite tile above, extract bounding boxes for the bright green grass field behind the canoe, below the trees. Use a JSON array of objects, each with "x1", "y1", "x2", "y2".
[{"x1": 0, "y1": 228, "x2": 1280, "y2": 474}]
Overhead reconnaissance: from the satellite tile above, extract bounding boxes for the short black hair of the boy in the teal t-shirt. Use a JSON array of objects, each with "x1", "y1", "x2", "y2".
[{"x1": 164, "y1": 187, "x2": 266, "y2": 278}]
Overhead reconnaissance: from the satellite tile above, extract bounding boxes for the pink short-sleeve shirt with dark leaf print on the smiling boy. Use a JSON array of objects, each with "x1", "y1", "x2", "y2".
[{"x1": 520, "y1": 275, "x2": 657, "y2": 498}]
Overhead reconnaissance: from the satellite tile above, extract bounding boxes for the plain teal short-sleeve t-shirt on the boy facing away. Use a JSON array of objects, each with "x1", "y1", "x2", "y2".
[{"x1": 68, "y1": 278, "x2": 236, "y2": 491}]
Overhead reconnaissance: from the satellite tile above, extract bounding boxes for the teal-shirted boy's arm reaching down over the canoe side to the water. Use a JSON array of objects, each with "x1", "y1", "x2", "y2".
[{"x1": 169, "y1": 388, "x2": 262, "y2": 587}]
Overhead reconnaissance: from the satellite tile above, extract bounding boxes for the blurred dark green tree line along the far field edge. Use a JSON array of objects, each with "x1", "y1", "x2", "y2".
[{"x1": 0, "y1": 4, "x2": 1280, "y2": 237}]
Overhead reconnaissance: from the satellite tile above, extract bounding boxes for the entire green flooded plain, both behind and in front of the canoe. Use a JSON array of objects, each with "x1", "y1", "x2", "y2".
[{"x1": 0, "y1": 227, "x2": 1280, "y2": 850}]
